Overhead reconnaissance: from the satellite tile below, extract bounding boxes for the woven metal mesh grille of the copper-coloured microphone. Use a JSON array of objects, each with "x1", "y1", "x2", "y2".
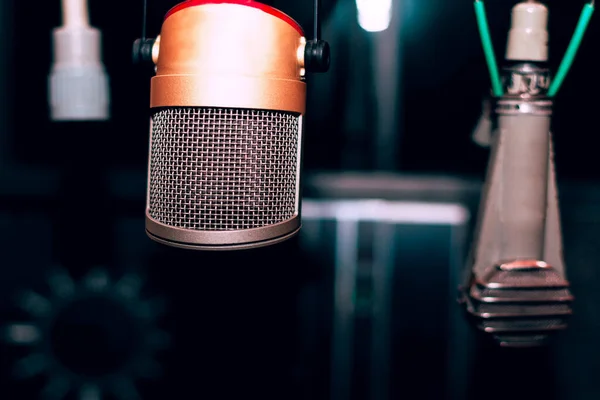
[{"x1": 148, "y1": 107, "x2": 300, "y2": 231}]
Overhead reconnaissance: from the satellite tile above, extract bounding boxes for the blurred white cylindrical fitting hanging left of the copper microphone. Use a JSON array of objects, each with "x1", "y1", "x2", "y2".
[{"x1": 48, "y1": 0, "x2": 110, "y2": 121}]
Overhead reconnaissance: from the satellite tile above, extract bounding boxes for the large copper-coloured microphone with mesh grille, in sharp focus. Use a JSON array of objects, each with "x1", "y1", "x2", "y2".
[{"x1": 134, "y1": 0, "x2": 329, "y2": 250}]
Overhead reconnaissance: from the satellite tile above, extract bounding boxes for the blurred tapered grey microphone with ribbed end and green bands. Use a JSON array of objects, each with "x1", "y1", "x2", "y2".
[{"x1": 460, "y1": 1, "x2": 593, "y2": 347}]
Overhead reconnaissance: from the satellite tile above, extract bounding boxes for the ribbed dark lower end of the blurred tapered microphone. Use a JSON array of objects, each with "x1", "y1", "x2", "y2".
[{"x1": 460, "y1": 260, "x2": 573, "y2": 347}]
